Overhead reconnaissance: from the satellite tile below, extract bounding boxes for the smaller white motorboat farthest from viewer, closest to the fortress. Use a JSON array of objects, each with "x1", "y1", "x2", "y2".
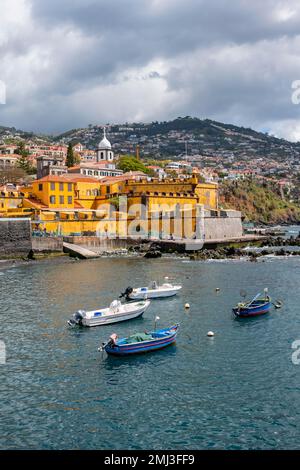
[{"x1": 120, "y1": 281, "x2": 182, "y2": 300}]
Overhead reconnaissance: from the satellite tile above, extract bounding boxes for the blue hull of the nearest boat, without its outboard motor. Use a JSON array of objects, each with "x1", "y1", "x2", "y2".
[{"x1": 105, "y1": 327, "x2": 177, "y2": 356}]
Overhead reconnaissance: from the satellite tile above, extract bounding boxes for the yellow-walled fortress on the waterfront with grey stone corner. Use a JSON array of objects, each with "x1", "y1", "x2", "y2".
[{"x1": 0, "y1": 172, "x2": 241, "y2": 238}]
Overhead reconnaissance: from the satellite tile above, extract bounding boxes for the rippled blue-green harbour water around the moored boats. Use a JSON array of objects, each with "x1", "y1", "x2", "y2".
[{"x1": 0, "y1": 257, "x2": 300, "y2": 449}]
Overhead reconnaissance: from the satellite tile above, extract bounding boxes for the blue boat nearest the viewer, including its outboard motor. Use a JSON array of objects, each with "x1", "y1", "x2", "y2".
[{"x1": 98, "y1": 324, "x2": 179, "y2": 356}]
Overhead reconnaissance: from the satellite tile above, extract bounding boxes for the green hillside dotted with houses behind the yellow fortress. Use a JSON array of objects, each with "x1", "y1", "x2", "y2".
[{"x1": 0, "y1": 118, "x2": 300, "y2": 202}]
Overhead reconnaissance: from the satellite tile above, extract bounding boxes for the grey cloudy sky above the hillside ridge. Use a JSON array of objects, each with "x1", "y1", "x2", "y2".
[{"x1": 0, "y1": 0, "x2": 300, "y2": 140}]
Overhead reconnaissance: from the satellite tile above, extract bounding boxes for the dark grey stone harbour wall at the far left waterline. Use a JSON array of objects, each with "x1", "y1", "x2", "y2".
[{"x1": 0, "y1": 218, "x2": 31, "y2": 258}]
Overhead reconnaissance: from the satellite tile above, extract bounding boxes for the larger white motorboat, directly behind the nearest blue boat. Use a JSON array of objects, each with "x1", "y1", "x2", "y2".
[{"x1": 68, "y1": 300, "x2": 150, "y2": 326}]
